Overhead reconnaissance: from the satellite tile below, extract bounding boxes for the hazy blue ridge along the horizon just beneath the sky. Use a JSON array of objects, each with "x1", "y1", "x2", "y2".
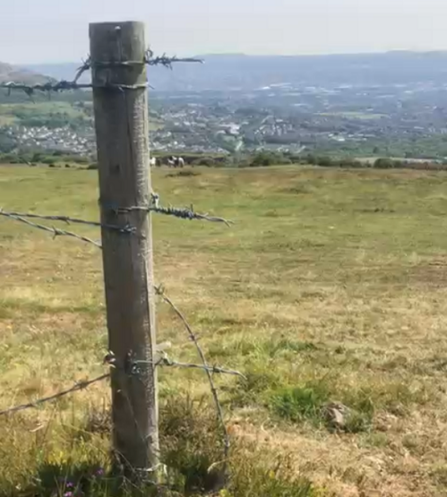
[{"x1": 26, "y1": 51, "x2": 447, "y2": 91}]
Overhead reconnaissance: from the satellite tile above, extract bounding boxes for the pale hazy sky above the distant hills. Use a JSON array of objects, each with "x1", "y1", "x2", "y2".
[{"x1": 0, "y1": 0, "x2": 447, "y2": 63}]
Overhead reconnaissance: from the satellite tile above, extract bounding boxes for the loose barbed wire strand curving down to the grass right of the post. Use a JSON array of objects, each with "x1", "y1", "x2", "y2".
[{"x1": 154, "y1": 285, "x2": 230, "y2": 474}]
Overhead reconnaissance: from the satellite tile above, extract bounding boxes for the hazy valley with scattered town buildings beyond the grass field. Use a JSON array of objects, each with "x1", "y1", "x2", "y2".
[{"x1": 0, "y1": 54, "x2": 447, "y2": 161}]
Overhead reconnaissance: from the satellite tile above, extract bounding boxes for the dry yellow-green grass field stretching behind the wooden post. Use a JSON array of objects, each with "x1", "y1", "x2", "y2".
[{"x1": 0, "y1": 167, "x2": 447, "y2": 497}]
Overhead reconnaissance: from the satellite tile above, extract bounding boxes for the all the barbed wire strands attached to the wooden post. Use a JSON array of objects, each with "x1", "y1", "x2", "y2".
[{"x1": 0, "y1": 35, "x2": 238, "y2": 486}]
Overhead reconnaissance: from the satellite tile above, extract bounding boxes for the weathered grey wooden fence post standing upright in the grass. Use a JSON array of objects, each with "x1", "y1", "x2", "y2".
[{"x1": 90, "y1": 22, "x2": 159, "y2": 480}]
